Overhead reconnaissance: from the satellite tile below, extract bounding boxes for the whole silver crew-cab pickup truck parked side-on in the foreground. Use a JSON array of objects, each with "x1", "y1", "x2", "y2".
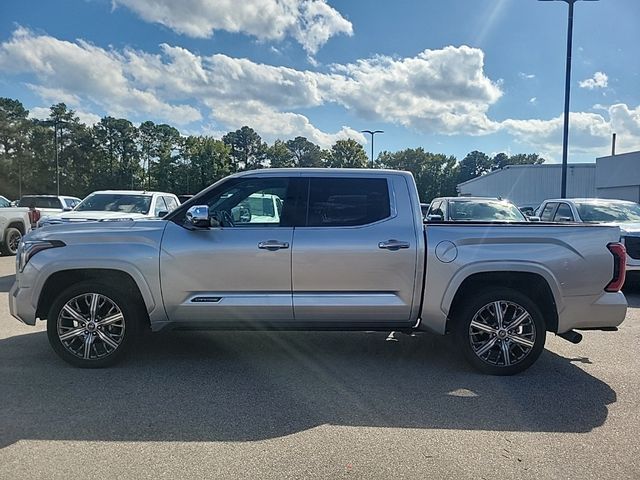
[{"x1": 9, "y1": 169, "x2": 627, "y2": 375}]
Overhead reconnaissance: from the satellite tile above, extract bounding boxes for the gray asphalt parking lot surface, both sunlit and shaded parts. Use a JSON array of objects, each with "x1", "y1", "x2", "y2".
[{"x1": 0, "y1": 253, "x2": 640, "y2": 479}]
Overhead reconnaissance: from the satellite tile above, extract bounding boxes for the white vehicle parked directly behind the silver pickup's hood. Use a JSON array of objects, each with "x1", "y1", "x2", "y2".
[{"x1": 38, "y1": 190, "x2": 180, "y2": 226}]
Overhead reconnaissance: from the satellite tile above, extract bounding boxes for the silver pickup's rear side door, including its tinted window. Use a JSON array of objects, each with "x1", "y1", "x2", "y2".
[{"x1": 292, "y1": 174, "x2": 422, "y2": 327}]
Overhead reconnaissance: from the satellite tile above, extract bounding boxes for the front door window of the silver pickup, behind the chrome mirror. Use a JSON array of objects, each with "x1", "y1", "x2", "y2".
[{"x1": 206, "y1": 177, "x2": 293, "y2": 227}]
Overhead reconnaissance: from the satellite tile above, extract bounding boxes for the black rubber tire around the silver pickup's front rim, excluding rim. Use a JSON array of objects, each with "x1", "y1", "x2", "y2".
[{"x1": 47, "y1": 281, "x2": 141, "y2": 368}]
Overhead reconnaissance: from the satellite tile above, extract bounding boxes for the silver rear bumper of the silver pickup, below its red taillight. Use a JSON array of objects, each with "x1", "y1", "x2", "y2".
[{"x1": 557, "y1": 292, "x2": 627, "y2": 333}]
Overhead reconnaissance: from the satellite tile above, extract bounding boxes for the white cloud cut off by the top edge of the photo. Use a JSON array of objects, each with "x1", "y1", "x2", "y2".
[{"x1": 112, "y1": 0, "x2": 353, "y2": 55}]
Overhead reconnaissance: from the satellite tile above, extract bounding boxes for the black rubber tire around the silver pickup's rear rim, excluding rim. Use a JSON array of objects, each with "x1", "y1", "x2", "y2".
[{"x1": 454, "y1": 287, "x2": 547, "y2": 375}]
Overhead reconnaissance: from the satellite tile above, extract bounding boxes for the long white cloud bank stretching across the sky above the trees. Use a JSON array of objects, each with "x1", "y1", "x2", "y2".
[{"x1": 0, "y1": 28, "x2": 640, "y2": 157}]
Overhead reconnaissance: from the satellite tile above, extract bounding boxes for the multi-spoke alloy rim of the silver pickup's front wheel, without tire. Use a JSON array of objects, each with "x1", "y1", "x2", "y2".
[{"x1": 57, "y1": 293, "x2": 125, "y2": 360}]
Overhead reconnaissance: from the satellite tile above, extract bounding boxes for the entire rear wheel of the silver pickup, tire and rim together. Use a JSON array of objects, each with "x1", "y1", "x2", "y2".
[{"x1": 453, "y1": 287, "x2": 547, "y2": 375}]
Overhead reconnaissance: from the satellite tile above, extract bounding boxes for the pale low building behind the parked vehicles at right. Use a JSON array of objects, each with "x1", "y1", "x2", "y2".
[{"x1": 458, "y1": 151, "x2": 640, "y2": 206}]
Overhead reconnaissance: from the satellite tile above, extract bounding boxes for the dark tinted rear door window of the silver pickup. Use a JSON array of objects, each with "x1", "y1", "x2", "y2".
[{"x1": 307, "y1": 178, "x2": 391, "y2": 227}]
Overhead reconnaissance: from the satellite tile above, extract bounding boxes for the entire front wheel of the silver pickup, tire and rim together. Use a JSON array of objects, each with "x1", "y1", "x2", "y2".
[{"x1": 47, "y1": 281, "x2": 144, "y2": 368}]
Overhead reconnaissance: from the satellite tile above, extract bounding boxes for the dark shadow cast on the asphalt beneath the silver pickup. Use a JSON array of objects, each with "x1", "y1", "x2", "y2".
[{"x1": 0, "y1": 332, "x2": 616, "y2": 447}]
